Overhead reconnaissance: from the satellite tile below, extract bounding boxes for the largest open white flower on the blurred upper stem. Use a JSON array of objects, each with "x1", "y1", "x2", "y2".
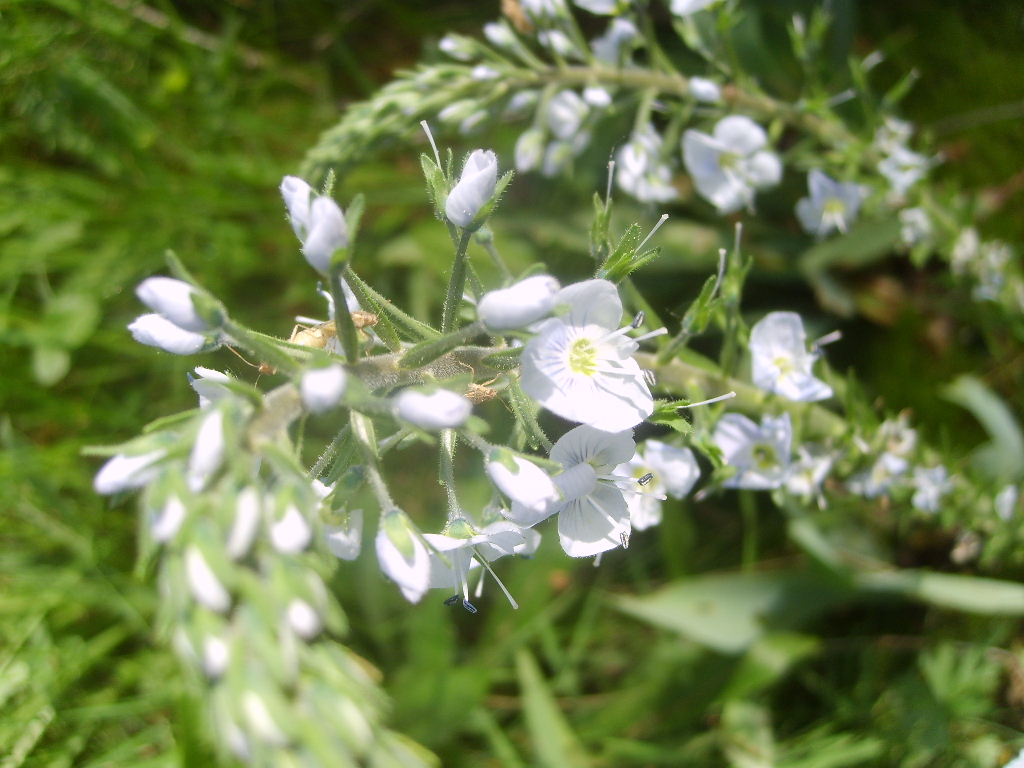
[{"x1": 683, "y1": 115, "x2": 782, "y2": 213}]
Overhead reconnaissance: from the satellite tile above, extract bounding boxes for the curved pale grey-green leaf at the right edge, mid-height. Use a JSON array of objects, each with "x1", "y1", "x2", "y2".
[{"x1": 942, "y1": 376, "x2": 1024, "y2": 482}]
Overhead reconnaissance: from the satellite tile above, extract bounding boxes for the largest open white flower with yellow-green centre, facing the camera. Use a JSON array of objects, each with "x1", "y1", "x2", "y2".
[{"x1": 521, "y1": 280, "x2": 654, "y2": 432}]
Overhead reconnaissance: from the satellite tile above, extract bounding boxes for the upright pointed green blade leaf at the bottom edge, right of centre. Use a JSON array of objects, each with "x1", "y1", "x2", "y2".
[{"x1": 515, "y1": 648, "x2": 592, "y2": 768}]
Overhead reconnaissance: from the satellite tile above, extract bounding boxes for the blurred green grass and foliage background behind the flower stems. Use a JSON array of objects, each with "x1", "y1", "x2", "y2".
[{"x1": 6, "y1": 0, "x2": 1024, "y2": 768}]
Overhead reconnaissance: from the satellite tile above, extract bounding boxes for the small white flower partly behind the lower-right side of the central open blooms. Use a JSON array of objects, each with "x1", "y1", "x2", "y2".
[{"x1": 615, "y1": 440, "x2": 700, "y2": 530}]
